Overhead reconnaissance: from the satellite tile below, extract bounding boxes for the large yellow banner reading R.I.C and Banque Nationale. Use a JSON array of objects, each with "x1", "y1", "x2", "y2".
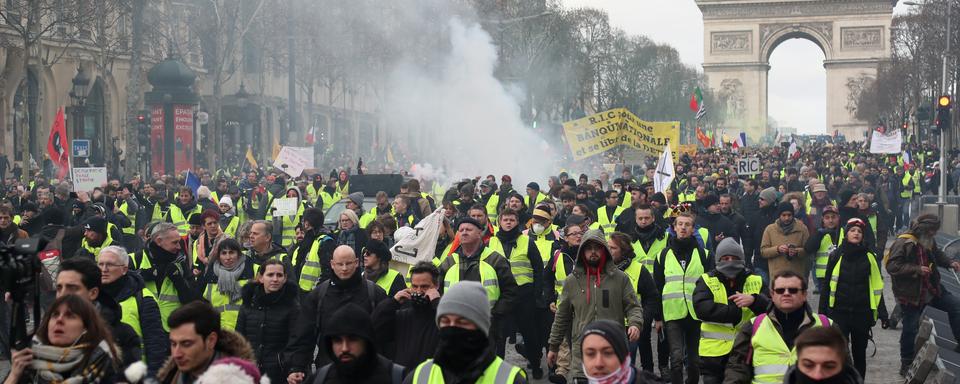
[{"x1": 563, "y1": 108, "x2": 680, "y2": 160}]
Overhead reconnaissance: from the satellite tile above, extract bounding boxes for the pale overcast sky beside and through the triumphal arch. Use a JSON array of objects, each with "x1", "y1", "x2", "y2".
[{"x1": 562, "y1": 0, "x2": 906, "y2": 133}]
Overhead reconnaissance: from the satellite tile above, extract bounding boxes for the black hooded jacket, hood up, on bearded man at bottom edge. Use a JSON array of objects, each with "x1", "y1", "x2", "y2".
[{"x1": 312, "y1": 304, "x2": 403, "y2": 383}]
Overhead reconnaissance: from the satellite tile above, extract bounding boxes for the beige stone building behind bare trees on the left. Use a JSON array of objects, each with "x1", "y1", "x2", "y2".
[{"x1": 0, "y1": 0, "x2": 383, "y2": 178}]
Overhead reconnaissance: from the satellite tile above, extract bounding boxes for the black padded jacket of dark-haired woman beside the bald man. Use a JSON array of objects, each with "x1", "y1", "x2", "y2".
[{"x1": 237, "y1": 281, "x2": 300, "y2": 383}]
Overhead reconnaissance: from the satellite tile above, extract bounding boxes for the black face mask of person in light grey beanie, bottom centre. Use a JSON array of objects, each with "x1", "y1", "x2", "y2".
[{"x1": 433, "y1": 327, "x2": 490, "y2": 372}]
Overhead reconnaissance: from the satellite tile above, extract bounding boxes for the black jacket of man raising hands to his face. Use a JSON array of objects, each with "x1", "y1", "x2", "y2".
[{"x1": 373, "y1": 297, "x2": 440, "y2": 368}]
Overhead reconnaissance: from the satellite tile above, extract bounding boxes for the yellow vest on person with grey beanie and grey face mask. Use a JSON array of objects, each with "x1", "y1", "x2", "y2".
[{"x1": 700, "y1": 273, "x2": 763, "y2": 357}]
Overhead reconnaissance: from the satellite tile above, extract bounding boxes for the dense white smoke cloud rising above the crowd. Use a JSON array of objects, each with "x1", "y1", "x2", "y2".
[{"x1": 384, "y1": 17, "x2": 558, "y2": 186}]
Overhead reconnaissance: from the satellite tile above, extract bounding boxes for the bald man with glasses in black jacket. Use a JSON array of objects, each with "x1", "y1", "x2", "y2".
[{"x1": 286, "y1": 245, "x2": 387, "y2": 384}]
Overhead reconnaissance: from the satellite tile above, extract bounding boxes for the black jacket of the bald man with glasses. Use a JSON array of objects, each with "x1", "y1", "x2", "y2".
[{"x1": 285, "y1": 271, "x2": 387, "y2": 374}]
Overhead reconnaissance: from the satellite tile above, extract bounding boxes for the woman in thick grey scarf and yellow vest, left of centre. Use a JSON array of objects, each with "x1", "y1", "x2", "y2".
[{"x1": 200, "y1": 238, "x2": 254, "y2": 331}]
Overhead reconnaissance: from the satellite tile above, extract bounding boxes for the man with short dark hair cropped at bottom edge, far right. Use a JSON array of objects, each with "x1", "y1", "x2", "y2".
[{"x1": 783, "y1": 327, "x2": 863, "y2": 384}]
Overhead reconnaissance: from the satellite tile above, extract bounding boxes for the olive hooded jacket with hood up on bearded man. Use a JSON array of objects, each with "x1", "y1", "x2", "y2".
[{"x1": 548, "y1": 230, "x2": 643, "y2": 377}]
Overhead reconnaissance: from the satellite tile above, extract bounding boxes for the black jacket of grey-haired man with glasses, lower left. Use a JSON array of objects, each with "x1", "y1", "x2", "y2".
[{"x1": 102, "y1": 271, "x2": 170, "y2": 375}]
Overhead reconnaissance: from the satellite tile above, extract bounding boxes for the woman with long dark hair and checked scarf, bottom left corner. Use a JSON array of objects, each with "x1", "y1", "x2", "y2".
[{"x1": 4, "y1": 294, "x2": 120, "y2": 384}]
